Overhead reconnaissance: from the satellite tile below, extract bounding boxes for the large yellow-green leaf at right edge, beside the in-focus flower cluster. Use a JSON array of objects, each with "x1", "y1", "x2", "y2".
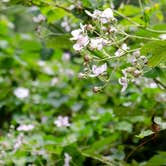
[{"x1": 141, "y1": 41, "x2": 166, "y2": 67}]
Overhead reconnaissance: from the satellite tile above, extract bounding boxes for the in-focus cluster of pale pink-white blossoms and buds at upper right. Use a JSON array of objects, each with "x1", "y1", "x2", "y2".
[{"x1": 71, "y1": 8, "x2": 154, "y2": 92}]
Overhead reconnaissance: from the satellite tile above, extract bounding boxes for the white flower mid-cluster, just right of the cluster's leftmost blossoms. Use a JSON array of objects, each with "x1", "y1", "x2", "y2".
[{"x1": 90, "y1": 37, "x2": 107, "y2": 50}]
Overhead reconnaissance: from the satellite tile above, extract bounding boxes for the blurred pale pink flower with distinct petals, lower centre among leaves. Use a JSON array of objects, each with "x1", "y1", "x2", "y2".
[{"x1": 54, "y1": 116, "x2": 70, "y2": 127}]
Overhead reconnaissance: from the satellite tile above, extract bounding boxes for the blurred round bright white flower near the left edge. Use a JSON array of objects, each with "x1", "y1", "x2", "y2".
[{"x1": 14, "y1": 87, "x2": 29, "y2": 99}]
